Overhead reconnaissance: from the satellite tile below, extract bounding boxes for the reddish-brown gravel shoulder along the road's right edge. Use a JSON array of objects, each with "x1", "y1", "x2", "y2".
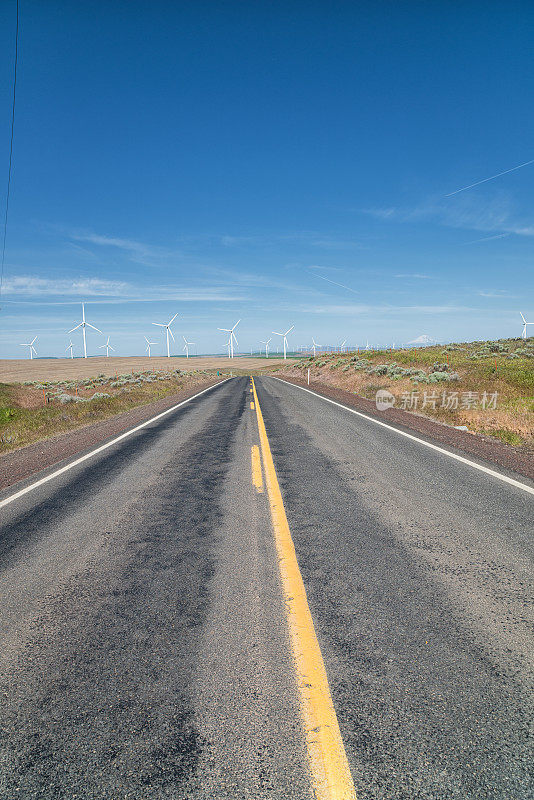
[{"x1": 283, "y1": 376, "x2": 534, "y2": 480}]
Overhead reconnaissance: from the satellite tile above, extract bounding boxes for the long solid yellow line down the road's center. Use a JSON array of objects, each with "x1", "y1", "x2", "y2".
[{"x1": 251, "y1": 379, "x2": 356, "y2": 800}]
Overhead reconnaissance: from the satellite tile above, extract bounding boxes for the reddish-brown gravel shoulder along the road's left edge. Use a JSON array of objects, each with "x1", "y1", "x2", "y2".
[{"x1": 0, "y1": 380, "x2": 220, "y2": 490}]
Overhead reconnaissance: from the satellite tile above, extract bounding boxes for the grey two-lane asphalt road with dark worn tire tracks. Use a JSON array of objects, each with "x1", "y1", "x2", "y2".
[{"x1": 0, "y1": 378, "x2": 534, "y2": 800}]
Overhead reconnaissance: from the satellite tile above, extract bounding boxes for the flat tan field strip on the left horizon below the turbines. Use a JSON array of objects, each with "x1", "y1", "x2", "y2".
[{"x1": 0, "y1": 356, "x2": 283, "y2": 383}]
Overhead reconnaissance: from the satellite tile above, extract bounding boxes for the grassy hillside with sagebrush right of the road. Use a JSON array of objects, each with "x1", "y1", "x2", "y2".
[{"x1": 276, "y1": 339, "x2": 534, "y2": 447}]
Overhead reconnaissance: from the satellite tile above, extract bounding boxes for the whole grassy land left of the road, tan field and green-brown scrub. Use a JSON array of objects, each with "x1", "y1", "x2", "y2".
[{"x1": 0, "y1": 357, "x2": 292, "y2": 453}]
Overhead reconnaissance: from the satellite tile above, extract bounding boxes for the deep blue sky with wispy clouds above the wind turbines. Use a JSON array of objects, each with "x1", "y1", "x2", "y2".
[{"x1": 0, "y1": 0, "x2": 534, "y2": 358}]
